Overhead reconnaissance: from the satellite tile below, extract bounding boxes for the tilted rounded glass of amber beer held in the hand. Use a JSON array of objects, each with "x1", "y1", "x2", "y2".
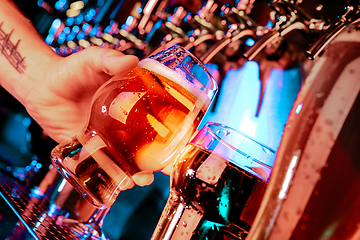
[{"x1": 51, "y1": 46, "x2": 217, "y2": 208}]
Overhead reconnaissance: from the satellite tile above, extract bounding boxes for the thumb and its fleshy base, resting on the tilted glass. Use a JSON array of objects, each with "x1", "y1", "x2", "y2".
[{"x1": 53, "y1": 47, "x2": 139, "y2": 98}]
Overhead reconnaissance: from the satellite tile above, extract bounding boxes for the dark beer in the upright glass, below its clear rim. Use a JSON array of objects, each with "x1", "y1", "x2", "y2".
[{"x1": 152, "y1": 144, "x2": 267, "y2": 240}]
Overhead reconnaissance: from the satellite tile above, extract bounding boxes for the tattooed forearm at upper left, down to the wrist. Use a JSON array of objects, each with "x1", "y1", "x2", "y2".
[{"x1": 0, "y1": 0, "x2": 59, "y2": 103}]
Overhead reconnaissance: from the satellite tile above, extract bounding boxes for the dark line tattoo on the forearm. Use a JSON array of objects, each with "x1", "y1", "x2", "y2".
[{"x1": 0, "y1": 22, "x2": 26, "y2": 73}]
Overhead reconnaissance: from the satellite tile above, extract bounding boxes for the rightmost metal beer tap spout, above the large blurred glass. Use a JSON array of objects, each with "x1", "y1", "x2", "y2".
[{"x1": 305, "y1": 5, "x2": 360, "y2": 60}]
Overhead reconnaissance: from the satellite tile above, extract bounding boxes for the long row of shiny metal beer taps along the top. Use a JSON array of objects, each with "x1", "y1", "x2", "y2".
[{"x1": 48, "y1": 0, "x2": 359, "y2": 72}]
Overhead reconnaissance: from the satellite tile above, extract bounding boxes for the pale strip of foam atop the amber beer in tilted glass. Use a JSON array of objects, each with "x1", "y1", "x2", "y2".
[{"x1": 138, "y1": 58, "x2": 208, "y2": 102}]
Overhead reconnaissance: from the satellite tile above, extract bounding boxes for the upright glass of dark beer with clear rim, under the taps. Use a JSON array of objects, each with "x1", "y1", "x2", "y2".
[{"x1": 151, "y1": 123, "x2": 275, "y2": 240}]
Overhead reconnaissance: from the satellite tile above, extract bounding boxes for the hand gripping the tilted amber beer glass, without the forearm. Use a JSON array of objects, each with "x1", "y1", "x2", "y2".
[{"x1": 24, "y1": 47, "x2": 138, "y2": 142}]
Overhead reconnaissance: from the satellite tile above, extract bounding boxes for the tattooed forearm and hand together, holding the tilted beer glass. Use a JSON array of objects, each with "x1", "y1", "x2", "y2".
[{"x1": 0, "y1": 0, "x2": 163, "y2": 186}]
